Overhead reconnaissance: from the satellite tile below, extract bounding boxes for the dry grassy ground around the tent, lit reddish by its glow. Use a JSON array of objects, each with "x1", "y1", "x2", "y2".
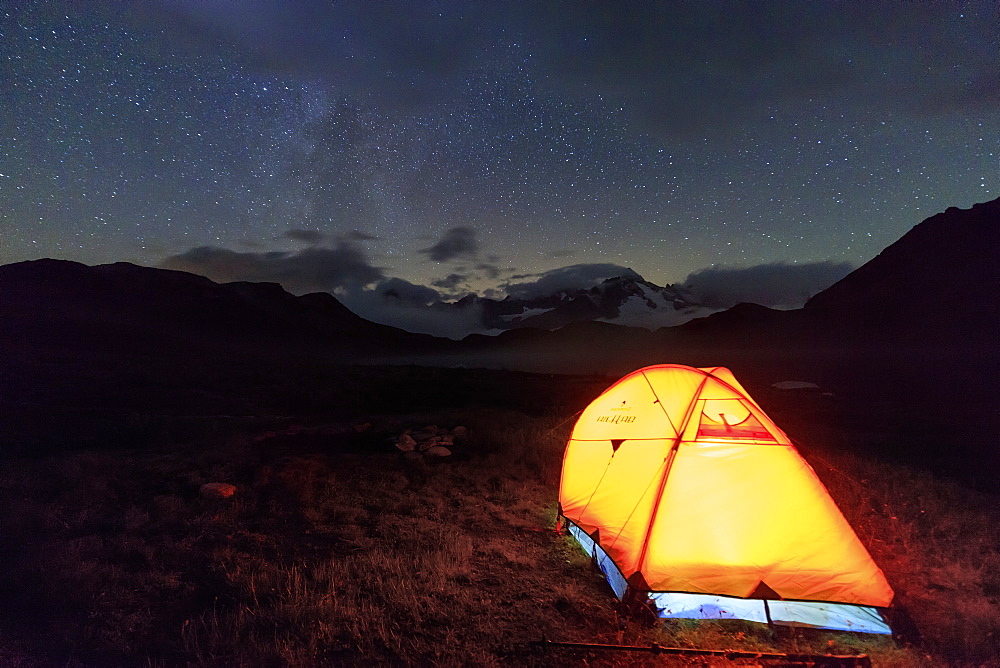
[{"x1": 0, "y1": 369, "x2": 1000, "y2": 666}]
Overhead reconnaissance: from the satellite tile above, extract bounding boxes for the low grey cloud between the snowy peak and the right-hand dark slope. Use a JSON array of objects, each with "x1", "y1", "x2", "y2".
[{"x1": 683, "y1": 262, "x2": 853, "y2": 308}]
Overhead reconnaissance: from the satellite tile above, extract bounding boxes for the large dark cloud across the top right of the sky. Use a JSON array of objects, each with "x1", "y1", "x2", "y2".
[{"x1": 529, "y1": 0, "x2": 1000, "y2": 135}]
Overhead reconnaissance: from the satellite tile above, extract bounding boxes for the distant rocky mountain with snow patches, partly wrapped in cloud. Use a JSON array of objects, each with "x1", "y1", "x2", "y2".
[{"x1": 438, "y1": 276, "x2": 718, "y2": 330}]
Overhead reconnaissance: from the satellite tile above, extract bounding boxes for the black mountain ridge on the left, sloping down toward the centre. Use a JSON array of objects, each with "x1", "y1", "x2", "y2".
[{"x1": 0, "y1": 259, "x2": 433, "y2": 360}]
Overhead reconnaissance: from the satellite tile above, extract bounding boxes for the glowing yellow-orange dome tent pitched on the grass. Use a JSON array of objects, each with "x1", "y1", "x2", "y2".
[{"x1": 559, "y1": 364, "x2": 893, "y2": 633}]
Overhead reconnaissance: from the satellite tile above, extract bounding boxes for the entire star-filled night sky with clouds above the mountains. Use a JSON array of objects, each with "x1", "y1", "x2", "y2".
[{"x1": 0, "y1": 0, "x2": 1000, "y2": 310}]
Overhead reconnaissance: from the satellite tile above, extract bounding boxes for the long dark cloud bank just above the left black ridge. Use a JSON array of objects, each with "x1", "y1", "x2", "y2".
[{"x1": 160, "y1": 243, "x2": 385, "y2": 294}]
